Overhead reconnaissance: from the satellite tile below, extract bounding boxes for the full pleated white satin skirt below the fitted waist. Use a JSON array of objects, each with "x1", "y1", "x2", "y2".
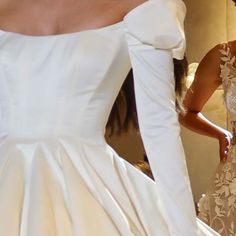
[{"x1": 0, "y1": 138, "x2": 217, "y2": 236}]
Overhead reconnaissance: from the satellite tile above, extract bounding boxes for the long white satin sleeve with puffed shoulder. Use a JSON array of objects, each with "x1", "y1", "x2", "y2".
[{"x1": 124, "y1": 0, "x2": 200, "y2": 236}]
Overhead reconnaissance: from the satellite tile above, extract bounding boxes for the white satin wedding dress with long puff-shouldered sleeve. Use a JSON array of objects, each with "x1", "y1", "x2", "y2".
[{"x1": 0, "y1": 0, "x2": 217, "y2": 236}]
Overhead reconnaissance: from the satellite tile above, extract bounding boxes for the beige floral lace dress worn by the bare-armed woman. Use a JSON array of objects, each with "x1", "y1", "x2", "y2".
[{"x1": 199, "y1": 44, "x2": 236, "y2": 236}]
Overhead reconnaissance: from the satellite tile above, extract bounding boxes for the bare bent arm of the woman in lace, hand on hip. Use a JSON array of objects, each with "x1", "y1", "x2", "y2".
[{"x1": 179, "y1": 45, "x2": 231, "y2": 160}]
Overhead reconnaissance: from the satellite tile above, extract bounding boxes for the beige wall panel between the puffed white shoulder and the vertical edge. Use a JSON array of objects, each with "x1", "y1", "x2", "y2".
[{"x1": 185, "y1": 0, "x2": 226, "y2": 62}]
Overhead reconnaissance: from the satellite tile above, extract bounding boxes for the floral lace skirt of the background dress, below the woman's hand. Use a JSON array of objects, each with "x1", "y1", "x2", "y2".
[{"x1": 199, "y1": 146, "x2": 236, "y2": 236}]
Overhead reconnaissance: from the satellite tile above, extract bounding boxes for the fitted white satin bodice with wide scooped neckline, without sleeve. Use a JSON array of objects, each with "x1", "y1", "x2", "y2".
[{"x1": 0, "y1": 22, "x2": 130, "y2": 142}]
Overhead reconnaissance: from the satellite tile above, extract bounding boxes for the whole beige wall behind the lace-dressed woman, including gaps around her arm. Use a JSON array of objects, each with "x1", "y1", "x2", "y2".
[{"x1": 182, "y1": 0, "x2": 236, "y2": 202}]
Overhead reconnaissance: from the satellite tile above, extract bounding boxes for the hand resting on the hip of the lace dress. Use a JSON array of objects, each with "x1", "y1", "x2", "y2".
[{"x1": 219, "y1": 131, "x2": 233, "y2": 162}]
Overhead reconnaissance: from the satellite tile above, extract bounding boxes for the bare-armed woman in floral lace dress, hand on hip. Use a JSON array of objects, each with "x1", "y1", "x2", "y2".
[{"x1": 180, "y1": 1, "x2": 236, "y2": 236}]
